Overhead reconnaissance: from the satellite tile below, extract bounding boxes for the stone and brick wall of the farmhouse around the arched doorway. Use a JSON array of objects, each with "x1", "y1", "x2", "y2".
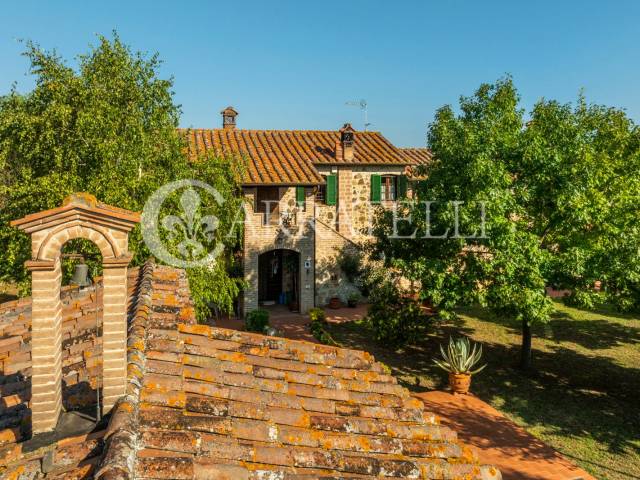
[{"x1": 243, "y1": 165, "x2": 405, "y2": 313}]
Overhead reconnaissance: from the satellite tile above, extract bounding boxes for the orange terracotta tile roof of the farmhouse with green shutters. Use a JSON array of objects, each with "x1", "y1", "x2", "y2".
[{"x1": 180, "y1": 129, "x2": 423, "y2": 185}]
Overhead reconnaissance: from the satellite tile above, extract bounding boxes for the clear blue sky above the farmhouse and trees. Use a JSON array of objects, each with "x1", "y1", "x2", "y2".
[{"x1": 0, "y1": 0, "x2": 640, "y2": 146}]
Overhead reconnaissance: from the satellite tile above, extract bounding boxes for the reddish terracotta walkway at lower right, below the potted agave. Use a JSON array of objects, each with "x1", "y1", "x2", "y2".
[{"x1": 416, "y1": 391, "x2": 595, "y2": 480}]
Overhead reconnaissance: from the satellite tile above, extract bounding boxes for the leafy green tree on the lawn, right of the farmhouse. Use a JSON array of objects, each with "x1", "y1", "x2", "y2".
[{"x1": 371, "y1": 78, "x2": 640, "y2": 368}]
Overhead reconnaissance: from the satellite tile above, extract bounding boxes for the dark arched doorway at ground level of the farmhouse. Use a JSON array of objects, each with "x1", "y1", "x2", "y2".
[{"x1": 258, "y1": 248, "x2": 300, "y2": 311}]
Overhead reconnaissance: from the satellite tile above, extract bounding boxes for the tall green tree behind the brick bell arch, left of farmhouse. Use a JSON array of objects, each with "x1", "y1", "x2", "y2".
[{"x1": 0, "y1": 33, "x2": 241, "y2": 319}]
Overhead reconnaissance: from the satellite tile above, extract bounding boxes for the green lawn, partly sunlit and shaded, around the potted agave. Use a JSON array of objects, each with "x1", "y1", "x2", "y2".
[{"x1": 328, "y1": 303, "x2": 640, "y2": 480}]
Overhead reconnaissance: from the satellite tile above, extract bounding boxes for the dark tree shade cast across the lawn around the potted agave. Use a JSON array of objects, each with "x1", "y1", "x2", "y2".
[{"x1": 331, "y1": 312, "x2": 640, "y2": 468}]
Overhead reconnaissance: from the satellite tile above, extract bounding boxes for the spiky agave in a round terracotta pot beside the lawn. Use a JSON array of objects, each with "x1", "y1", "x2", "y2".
[{"x1": 433, "y1": 337, "x2": 487, "y2": 395}]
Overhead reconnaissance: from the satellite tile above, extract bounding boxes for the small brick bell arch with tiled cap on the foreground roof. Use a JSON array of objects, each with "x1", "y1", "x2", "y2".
[{"x1": 11, "y1": 193, "x2": 140, "y2": 434}]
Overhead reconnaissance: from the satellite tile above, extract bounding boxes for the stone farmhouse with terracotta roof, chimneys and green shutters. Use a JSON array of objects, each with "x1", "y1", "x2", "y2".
[{"x1": 184, "y1": 107, "x2": 431, "y2": 312}]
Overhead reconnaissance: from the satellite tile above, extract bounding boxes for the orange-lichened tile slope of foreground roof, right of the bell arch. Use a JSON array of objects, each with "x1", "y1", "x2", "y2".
[{"x1": 0, "y1": 263, "x2": 500, "y2": 480}]
